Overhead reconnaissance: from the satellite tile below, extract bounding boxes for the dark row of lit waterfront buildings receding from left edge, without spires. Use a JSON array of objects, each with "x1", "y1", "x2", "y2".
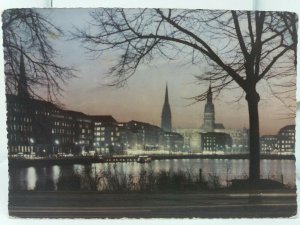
[{"x1": 6, "y1": 91, "x2": 183, "y2": 155}]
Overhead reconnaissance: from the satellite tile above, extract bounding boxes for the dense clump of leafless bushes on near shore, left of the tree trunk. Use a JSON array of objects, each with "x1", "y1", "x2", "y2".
[{"x1": 42, "y1": 165, "x2": 211, "y2": 193}]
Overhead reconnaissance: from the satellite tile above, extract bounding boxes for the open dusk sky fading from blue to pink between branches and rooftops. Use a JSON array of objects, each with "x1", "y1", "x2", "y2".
[{"x1": 34, "y1": 9, "x2": 294, "y2": 134}]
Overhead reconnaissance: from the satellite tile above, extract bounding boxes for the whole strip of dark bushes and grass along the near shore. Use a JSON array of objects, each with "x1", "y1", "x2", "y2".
[{"x1": 10, "y1": 164, "x2": 293, "y2": 193}]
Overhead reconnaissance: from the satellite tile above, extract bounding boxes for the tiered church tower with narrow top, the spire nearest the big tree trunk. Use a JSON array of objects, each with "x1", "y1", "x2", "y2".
[{"x1": 202, "y1": 85, "x2": 215, "y2": 132}]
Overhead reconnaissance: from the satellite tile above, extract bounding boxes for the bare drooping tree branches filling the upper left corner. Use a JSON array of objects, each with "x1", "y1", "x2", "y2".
[{"x1": 2, "y1": 9, "x2": 74, "y2": 101}]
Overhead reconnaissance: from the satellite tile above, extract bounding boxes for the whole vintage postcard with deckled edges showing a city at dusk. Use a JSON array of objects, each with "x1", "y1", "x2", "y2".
[{"x1": 2, "y1": 8, "x2": 298, "y2": 218}]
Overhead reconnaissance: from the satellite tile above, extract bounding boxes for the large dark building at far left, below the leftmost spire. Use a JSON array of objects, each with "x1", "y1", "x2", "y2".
[{"x1": 6, "y1": 95, "x2": 54, "y2": 155}]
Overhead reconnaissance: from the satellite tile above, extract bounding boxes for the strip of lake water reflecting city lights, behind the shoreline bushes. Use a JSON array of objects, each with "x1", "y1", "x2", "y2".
[{"x1": 9, "y1": 159, "x2": 295, "y2": 190}]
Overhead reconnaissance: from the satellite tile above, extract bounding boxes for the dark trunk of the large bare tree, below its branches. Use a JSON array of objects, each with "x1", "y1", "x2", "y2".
[{"x1": 246, "y1": 89, "x2": 260, "y2": 184}]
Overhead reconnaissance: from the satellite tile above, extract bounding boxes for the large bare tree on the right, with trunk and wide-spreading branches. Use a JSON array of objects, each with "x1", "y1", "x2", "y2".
[{"x1": 74, "y1": 9, "x2": 297, "y2": 183}]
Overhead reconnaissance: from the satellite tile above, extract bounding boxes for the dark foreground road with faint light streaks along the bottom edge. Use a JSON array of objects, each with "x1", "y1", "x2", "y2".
[{"x1": 9, "y1": 190, "x2": 297, "y2": 218}]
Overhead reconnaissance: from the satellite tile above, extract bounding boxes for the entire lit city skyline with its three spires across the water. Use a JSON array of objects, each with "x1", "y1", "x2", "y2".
[{"x1": 6, "y1": 50, "x2": 295, "y2": 156}]
